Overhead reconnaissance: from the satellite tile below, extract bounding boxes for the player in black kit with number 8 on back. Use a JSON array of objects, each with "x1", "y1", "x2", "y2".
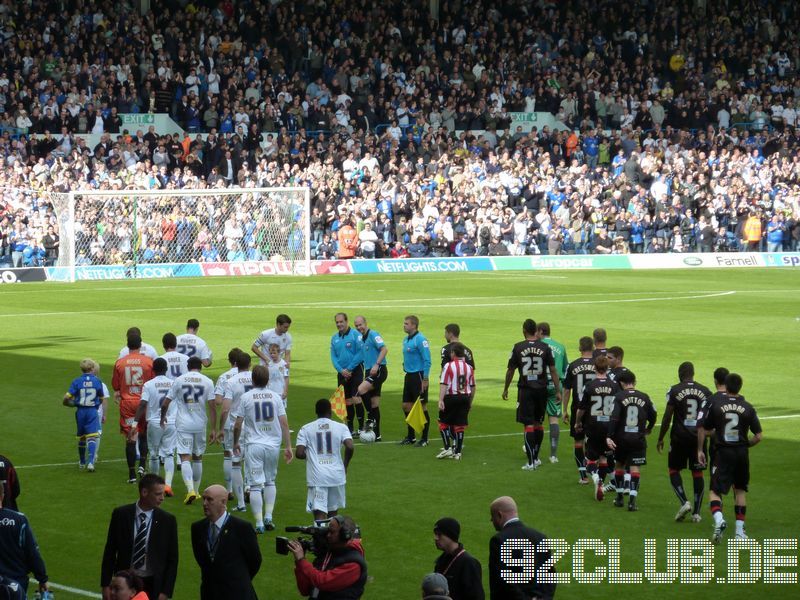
[{"x1": 606, "y1": 370, "x2": 656, "y2": 511}]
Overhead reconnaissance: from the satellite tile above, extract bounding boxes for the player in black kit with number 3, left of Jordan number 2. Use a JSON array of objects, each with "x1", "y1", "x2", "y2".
[{"x1": 656, "y1": 362, "x2": 711, "y2": 523}]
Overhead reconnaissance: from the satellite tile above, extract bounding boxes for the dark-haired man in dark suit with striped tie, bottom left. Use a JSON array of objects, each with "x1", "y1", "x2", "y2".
[{"x1": 100, "y1": 473, "x2": 178, "y2": 600}]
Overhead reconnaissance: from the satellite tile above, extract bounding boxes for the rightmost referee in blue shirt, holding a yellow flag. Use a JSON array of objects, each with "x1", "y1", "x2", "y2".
[{"x1": 400, "y1": 315, "x2": 431, "y2": 447}]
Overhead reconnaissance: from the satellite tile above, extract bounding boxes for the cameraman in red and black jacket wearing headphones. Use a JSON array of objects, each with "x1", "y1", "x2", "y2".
[{"x1": 288, "y1": 515, "x2": 367, "y2": 600}]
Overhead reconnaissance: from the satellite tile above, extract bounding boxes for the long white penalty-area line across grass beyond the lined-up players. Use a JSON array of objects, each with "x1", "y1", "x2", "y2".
[{"x1": 0, "y1": 290, "x2": 737, "y2": 318}]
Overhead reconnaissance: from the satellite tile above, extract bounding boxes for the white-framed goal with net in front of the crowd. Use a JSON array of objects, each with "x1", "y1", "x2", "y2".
[{"x1": 53, "y1": 188, "x2": 310, "y2": 281}]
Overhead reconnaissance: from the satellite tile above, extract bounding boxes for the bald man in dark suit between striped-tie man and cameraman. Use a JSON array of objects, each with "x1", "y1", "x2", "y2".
[{"x1": 192, "y1": 485, "x2": 261, "y2": 600}]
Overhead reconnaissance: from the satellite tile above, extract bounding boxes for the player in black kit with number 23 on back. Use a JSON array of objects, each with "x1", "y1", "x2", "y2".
[{"x1": 503, "y1": 319, "x2": 561, "y2": 471}]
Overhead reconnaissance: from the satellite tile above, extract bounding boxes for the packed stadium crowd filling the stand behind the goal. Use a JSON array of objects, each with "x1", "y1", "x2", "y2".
[{"x1": 0, "y1": 0, "x2": 800, "y2": 266}]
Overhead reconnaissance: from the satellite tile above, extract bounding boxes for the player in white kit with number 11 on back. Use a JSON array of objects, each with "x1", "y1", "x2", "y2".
[{"x1": 295, "y1": 398, "x2": 354, "y2": 520}]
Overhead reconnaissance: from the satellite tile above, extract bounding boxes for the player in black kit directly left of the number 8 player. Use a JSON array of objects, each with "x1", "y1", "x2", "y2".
[{"x1": 575, "y1": 355, "x2": 619, "y2": 501}]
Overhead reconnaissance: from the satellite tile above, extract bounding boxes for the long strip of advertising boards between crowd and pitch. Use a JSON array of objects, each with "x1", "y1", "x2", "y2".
[{"x1": 0, "y1": 252, "x2": 800, "y2": 284}]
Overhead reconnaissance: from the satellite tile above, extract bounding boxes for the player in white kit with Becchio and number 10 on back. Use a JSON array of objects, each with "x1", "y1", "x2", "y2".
[{"x1": 231, "y1": 365, "x2": 293, "y2": 533}]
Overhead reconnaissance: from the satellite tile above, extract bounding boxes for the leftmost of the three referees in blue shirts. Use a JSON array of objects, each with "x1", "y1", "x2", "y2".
[{"x1": 331, "y1": 313, "x2": 364, "y2": 436}]
